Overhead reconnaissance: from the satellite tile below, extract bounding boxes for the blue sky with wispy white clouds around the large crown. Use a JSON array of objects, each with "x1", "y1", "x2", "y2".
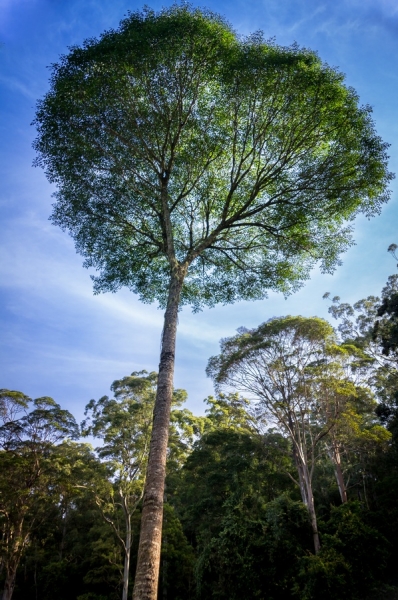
[{"x1": 0, "y1": 0, "x2": 398, "y2": 420}]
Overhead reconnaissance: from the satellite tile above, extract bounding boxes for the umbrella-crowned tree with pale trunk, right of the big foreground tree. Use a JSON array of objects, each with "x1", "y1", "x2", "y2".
[{"x1": 207, "y1": 316, "x2": 348, "y2": 553}]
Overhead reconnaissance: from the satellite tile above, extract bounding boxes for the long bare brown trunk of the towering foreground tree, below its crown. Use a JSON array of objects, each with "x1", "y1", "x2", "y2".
[{"x1": 133, "y1": 267, "x2": 185, "y2": 600}]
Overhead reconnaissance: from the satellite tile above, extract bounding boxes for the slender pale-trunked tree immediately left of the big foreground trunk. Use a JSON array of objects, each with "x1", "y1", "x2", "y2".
[{"x1": 82, "y1": 371, "x2": 157, "y2": 600}]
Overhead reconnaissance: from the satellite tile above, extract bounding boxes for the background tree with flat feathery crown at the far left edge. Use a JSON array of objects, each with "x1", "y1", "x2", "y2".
[{"x1": 0, "y1": 389, "x2": 78, "y2": 600}]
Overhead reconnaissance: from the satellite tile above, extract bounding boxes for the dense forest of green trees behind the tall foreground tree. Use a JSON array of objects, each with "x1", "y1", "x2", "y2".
[{"x1": 0, "y1": 276, "x2": 398, "y2": 600}]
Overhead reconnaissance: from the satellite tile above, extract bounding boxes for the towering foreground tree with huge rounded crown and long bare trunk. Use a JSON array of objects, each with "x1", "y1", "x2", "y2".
[{"x1": 35, "y1": 5, "x2": 391, "y2": 600}]
